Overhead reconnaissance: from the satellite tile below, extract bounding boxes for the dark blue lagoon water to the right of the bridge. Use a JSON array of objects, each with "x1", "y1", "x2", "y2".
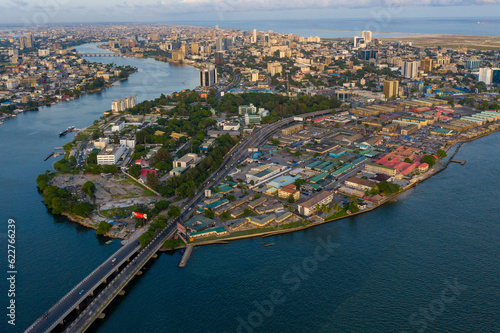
[{"x1": 94, "y1": 133, "x2": 500, "y2": 333}]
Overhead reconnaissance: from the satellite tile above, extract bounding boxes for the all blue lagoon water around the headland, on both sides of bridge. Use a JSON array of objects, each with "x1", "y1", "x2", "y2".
[{"x1": 0, "y1": 42, "x2": 500, "y2": 333}]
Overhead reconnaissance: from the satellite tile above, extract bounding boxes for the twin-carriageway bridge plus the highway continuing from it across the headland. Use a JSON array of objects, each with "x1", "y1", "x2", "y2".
[{"x1": 25, "y1": 109, "x2": 332, "y2": 333}]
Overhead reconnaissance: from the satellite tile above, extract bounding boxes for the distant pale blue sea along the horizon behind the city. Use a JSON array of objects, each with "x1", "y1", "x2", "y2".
[{"x1": 168, "y1": 17, "x2": 500, "y2": 38}]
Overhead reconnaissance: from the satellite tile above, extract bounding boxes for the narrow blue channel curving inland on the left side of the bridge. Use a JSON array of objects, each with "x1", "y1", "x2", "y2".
[{"x1": 0, "y1": 45, "x2": 198, "y2": 332}]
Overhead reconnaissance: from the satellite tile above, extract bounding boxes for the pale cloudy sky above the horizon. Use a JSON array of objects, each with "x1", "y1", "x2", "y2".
[{"x1": 0, "y1": 0, "x2": 500, "y2": 25}]
